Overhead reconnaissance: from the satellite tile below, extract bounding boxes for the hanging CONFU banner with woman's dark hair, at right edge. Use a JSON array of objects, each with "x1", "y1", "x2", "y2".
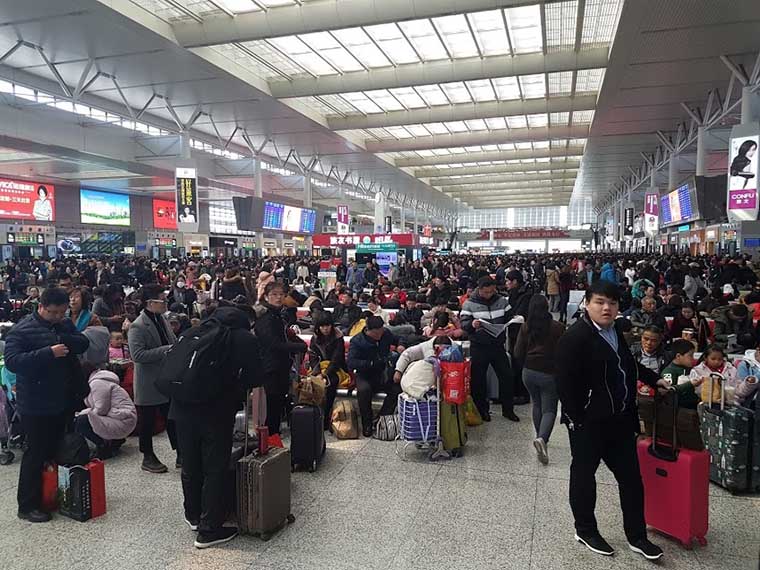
[{"x1": 726, "y1": 132, "x2": 760, "y2": 221}]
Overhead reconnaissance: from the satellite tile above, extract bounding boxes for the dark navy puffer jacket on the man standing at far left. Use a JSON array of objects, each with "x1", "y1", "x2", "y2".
[{"x1": 5, "y1": 311, "x2": 90, "y2": 416}]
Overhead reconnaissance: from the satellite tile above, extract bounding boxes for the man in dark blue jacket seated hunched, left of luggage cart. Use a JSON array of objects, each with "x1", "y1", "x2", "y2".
[{"x1": 348, "y1": 316, "x2": 403, "y2": 437}]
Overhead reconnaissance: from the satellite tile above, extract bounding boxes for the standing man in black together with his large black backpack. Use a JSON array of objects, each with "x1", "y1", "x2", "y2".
[{"x1": 167, "y1": 307, "x2": 262, "y2": 548}]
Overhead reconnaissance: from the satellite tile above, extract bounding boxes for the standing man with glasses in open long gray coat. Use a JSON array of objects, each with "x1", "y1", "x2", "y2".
[{"x1": 128, "y1": 284, "x2": 181, "y2": 473}]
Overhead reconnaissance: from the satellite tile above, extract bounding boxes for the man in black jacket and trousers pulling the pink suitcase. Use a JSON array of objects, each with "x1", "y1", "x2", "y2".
[{"x1": 556, "y1": 281, "x2": 667, "y2": 560}]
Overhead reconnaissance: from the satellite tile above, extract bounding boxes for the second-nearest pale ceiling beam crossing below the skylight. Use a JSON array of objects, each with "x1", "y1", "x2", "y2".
[{"x1": 269, "y1": 48, "x2": 608, "y2": 98}]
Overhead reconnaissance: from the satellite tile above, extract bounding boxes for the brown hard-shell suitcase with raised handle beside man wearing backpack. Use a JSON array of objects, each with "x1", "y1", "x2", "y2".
[{"x1": 236, "y1": 388, "x2": 295, "y2": 540}]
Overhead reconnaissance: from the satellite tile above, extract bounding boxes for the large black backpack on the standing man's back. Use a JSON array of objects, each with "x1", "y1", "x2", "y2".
[{"x1": 156, "y1": 318, "x2": 235, "y2": 404}]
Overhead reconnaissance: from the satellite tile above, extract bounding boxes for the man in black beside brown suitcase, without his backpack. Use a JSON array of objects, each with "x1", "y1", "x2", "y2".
[{"x1": 169, "y1": 307, "x2": 262, "y2": 548}]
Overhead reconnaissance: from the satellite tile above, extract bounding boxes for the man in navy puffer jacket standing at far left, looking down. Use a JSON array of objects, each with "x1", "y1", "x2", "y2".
[{"x1": 5, "y1": 288, "x2": 90, "y2": 522}]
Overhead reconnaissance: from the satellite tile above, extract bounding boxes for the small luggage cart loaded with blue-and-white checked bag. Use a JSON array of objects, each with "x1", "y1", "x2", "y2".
[{"x1": 396, "y1": 372, "x2": 451, "y2": 461}]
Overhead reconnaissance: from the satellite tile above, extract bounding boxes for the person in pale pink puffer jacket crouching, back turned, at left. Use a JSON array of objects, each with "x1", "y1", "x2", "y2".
[{"x1": 74, "y1": 370, "x2": 137, "y2": 459}]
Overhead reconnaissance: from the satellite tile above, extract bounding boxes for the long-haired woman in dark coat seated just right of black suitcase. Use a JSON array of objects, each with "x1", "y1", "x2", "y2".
[{"x1": 308, "y1": 312, "x2": 346, "y2": 430}]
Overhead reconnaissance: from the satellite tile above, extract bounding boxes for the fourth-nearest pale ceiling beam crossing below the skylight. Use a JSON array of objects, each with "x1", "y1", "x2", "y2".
[{"x1": 365, "y1": 125, "x2": 589, "y2": 152}]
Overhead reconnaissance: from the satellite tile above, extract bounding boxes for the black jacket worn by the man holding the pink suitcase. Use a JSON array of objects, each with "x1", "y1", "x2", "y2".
[{"x1": 555, "y1": 315, "x2": 659, "y2": 432}]
